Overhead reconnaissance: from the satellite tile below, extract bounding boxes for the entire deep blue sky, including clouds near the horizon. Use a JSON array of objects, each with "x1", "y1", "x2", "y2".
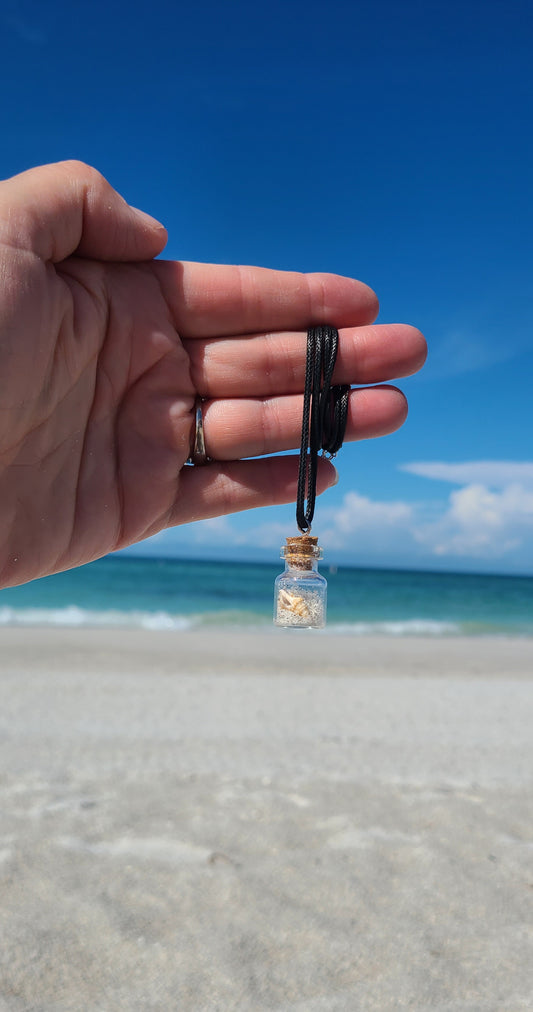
[{"x1": 0, "y1": 0, "x2": 533, "y2": 573}]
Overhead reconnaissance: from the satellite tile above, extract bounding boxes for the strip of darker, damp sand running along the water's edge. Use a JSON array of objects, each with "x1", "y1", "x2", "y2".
[{"x1": 0, "y1": 626, "x2": 533, "y2": 679}]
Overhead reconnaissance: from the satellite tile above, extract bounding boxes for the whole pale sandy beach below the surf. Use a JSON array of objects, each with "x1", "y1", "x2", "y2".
[{"x1": 0, "y1": 628, "x2": 533, "y2": 1012}]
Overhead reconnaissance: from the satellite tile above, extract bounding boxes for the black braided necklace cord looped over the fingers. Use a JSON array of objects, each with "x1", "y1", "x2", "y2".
[{"x1": 296, "y1": 326, "x2": 350, "y2": 534}]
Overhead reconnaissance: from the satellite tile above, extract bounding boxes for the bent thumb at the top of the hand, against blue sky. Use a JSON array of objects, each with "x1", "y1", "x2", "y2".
[{"x1": 0, "y1": 161, "x2": 167, "y2": 263}]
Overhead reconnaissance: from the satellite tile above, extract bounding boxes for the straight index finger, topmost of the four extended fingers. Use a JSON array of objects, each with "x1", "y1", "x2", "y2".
[{"x1": 151, "y1": 260, "x2": 379, "y2": 338}]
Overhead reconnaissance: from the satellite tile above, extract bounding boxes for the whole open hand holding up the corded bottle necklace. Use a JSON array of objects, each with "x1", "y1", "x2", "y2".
[{"x1": 0, "y1": 162, "x2": 426, "y2": 586}]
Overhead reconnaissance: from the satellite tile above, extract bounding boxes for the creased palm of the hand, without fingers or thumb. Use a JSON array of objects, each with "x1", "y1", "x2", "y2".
[{"x1": 0, "y1": 257, "x2": 194, "y2": 582}]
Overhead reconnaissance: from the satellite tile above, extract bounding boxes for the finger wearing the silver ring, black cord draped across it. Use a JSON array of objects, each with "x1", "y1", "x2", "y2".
[{"x1": 198, "y1": 387, "x2": 408, "y2": 460}]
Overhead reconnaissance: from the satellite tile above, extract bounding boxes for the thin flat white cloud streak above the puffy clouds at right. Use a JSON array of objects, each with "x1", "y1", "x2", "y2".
[{"x1": 399, "y1": 460, "x2": 533, "y2": 489}]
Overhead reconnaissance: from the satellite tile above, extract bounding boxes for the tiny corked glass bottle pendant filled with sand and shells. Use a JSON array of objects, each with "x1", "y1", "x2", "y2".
[{"x1": 274, "y1": 534, "x2": 328, "y2": 629}]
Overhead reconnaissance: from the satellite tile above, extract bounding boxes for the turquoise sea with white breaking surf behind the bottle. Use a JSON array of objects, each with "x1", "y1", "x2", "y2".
[{"x1": 0, "y1": 556, "x2": 533, "y2": 636}]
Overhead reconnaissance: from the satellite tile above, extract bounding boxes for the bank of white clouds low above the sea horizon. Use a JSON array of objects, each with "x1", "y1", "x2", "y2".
[{"x1": 127, "y1": 460, "x2": 533, "y2": 571}]
